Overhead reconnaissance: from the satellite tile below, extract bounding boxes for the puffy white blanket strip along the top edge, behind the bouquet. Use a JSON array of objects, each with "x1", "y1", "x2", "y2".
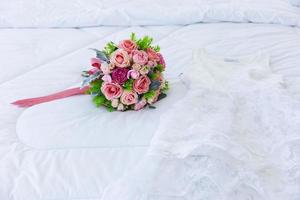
[{"x1": 0, "y1": 0, "x2": 300, "y2": 27}]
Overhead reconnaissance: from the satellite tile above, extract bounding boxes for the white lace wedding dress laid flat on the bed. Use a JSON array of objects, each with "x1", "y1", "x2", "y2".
[{"x1": 102, "y1": 50, "x2": 300, "y2": 200}]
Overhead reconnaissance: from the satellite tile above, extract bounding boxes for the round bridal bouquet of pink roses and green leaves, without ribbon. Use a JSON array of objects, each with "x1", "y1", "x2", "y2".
[{"x1": 82, "y1": 33, "x2": 168, "y2": 111}]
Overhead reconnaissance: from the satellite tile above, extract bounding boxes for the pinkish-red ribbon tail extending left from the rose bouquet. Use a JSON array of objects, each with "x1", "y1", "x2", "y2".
[{"x1": 11, "y1": 86, "x2": 89, "y2": 107}]
